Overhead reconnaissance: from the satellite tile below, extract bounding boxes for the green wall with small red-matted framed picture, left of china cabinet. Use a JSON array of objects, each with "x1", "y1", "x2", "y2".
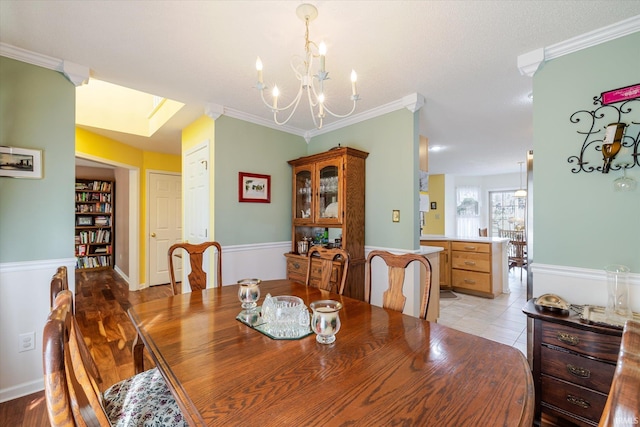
[{"x1": 214, "y1": 116, "x2": 307, "y2": 245}]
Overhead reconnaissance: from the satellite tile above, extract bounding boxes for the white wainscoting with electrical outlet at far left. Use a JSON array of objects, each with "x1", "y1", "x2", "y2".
[{"x1": 0, "y1": 258, "x2": 76, "y2": 402}]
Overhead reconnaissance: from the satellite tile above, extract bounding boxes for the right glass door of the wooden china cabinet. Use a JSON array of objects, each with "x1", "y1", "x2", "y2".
[{"x1": 316, "y1": 160, "x2": 342, "y2": 223}]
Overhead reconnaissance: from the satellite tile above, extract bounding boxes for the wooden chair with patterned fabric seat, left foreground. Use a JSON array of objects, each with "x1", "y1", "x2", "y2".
[{"x1": 42, "y1": 290, "x2": 186, "y2": 427}]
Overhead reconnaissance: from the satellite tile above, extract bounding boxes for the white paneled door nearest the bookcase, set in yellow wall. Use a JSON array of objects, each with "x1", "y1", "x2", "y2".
[{"x1": 148, "y1": 172, "x2": 182, "y2": 286}]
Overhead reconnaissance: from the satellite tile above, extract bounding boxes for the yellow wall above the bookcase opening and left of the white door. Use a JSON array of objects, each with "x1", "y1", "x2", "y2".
[{"x1": 76, "y1": 128, "x2": 182, "y2": 283}]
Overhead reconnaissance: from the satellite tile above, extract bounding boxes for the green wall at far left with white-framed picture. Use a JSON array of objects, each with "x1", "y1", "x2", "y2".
[{"x1": 0, "y1": 57, "x2": 75, "y2": 262}]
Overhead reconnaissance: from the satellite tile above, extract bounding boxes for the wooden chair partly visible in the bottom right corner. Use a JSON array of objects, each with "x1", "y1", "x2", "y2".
[{"x1": 598, "y1": 320, "x2": 640, "y2": 427}]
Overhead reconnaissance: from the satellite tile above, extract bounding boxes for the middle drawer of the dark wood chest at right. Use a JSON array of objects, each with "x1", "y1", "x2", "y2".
[{"x1": 540, "y1": 345, "x2": 616, "y2": 394}]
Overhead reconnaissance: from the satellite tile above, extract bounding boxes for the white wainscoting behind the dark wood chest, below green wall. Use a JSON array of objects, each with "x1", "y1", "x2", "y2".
[{"x1": 531, "y1": 263, "x2": 640, "y2": 313}]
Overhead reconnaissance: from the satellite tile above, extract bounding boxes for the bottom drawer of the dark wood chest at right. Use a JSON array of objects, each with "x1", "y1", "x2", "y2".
[{"x1": 541, "y1": 375, "x2": 607, "y2": 424}]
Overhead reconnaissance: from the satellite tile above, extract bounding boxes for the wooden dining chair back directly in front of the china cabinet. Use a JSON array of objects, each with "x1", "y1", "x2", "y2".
[{"x1": 306, "y1": 246, "x2": 349, "y2": 295}]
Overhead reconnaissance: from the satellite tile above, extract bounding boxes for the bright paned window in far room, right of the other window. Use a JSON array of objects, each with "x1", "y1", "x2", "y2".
[{"x1": 489, "y1": 190, "x2": 527, "y2": 237}]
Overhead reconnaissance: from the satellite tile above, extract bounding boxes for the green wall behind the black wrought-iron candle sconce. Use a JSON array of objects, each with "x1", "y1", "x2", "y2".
[{"x1": 533, "y1": 33, "x2": 640, "y2": 273}]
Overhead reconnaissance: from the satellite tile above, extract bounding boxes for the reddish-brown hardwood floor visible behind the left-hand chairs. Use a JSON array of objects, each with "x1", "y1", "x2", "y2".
[{"x1": 0, "y1": 269, "x2": 172, "y2": 427}]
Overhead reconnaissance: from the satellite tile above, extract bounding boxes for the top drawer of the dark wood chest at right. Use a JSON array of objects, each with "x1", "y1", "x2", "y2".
[{"x1": 541, "y1": 322, "x2": 621, "y2": 363}]
